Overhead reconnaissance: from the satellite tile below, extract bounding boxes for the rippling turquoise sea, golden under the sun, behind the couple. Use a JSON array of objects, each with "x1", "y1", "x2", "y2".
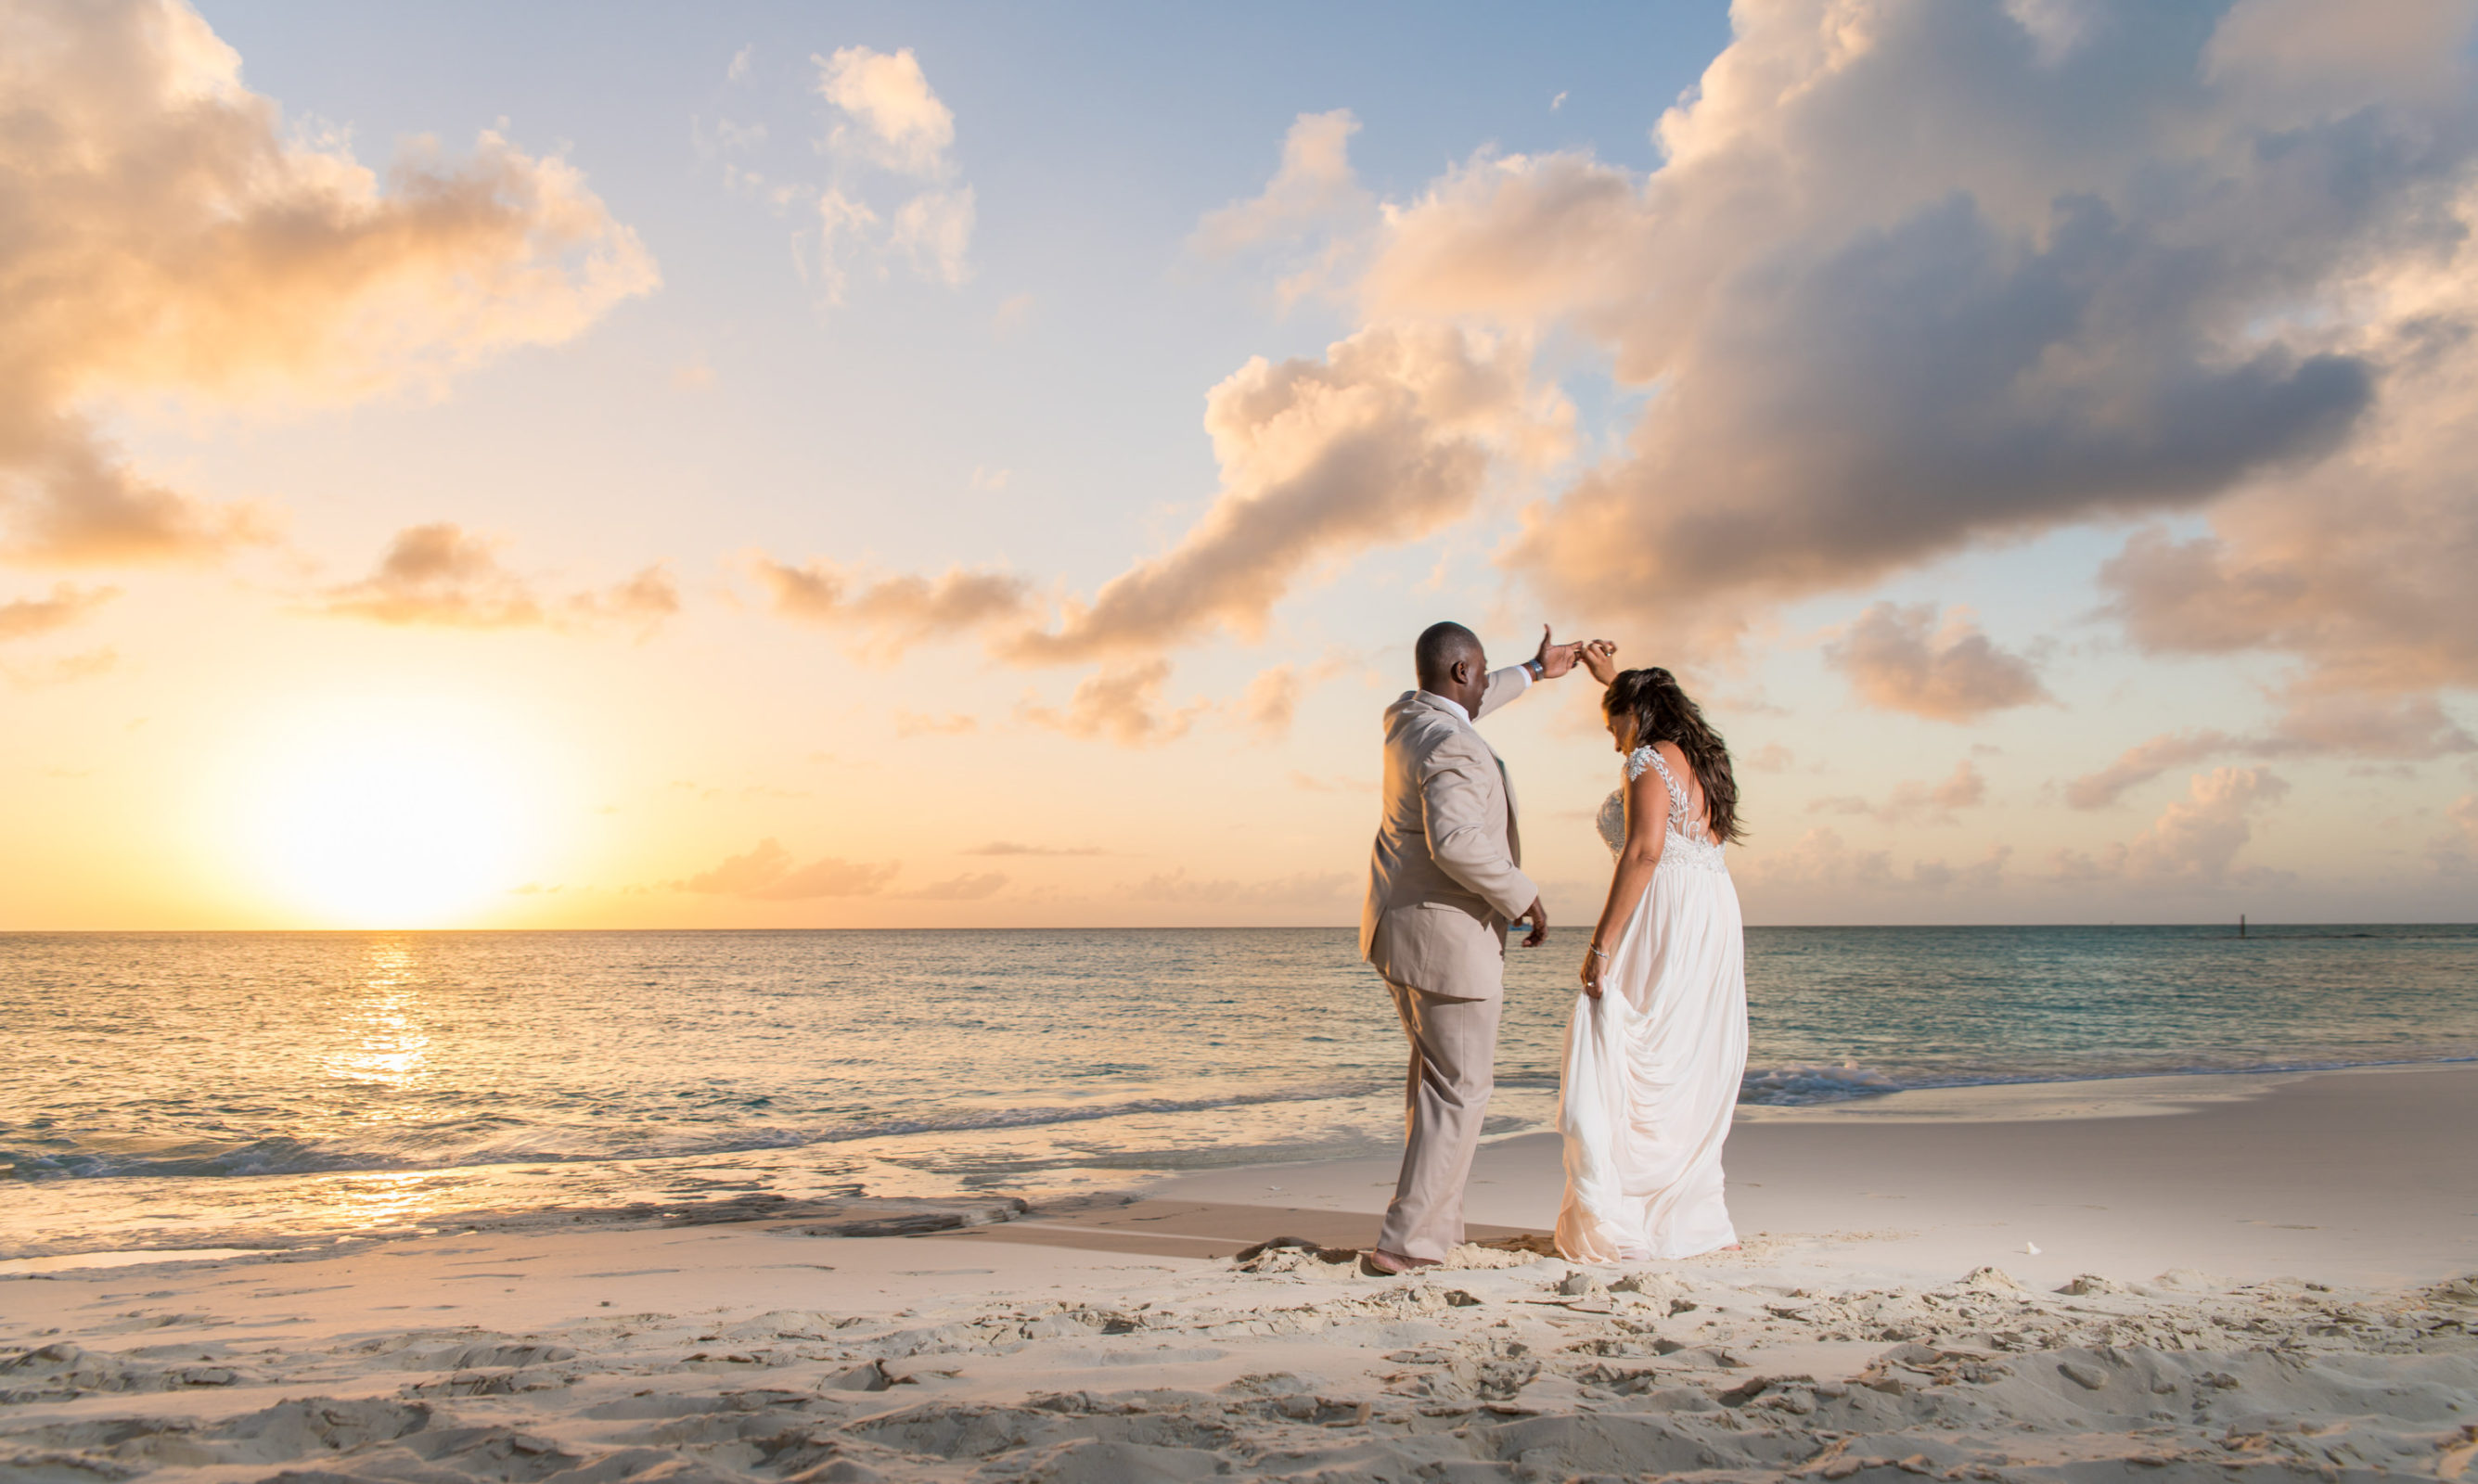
[{"x1": 0, "y1": 927, "x2": 2478, "y2": 1259}]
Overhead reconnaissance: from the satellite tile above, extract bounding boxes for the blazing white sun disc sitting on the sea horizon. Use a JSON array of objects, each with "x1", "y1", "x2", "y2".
[{"x1": 228, "y1": 701, "x2": 540, "y2": 927}]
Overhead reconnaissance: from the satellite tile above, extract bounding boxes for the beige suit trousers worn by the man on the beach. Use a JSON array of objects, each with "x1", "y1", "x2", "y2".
[{"x1": 1378, "y1": 981, "x2": 1504, "y2": 1261}]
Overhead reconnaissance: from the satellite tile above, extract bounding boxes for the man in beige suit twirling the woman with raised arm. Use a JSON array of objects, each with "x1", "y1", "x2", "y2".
[{"x1": 1360, "y1": 624, "x2": 1576, "y2": 1273}]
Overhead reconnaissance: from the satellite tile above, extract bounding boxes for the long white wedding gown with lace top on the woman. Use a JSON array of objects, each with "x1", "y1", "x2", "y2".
[{"x1": 1556, "y1": 748, "x2": 1747, "y2": 1263}]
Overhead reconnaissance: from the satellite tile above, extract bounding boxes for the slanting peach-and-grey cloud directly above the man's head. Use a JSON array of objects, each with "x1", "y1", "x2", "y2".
[{"x1": 1006, "y1": 325, "x2": 1573, "y2": 664}]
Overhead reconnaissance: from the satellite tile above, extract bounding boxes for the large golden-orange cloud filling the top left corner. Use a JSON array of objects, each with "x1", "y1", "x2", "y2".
[{"x1": 0, "y1": 0, "x2": 657, "y2": 565}]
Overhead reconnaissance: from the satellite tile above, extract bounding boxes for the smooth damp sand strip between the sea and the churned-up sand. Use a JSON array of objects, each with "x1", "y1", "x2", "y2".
[{"x1": 1090, "y1": 1063, "x2": 2478, "y2": 1286}]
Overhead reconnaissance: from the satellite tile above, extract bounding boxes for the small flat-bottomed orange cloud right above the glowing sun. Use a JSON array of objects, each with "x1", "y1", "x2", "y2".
[{"x1": 317, "y1": 520, "x2": 679, "y2": 632}]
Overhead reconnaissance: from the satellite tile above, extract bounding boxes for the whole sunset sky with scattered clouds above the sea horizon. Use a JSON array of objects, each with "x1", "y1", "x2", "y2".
[{"x1": 0, "y1": 0, "x2": 2478, "y2": 929}]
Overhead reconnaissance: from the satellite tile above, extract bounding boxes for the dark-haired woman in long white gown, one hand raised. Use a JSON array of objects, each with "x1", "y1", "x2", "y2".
[{"x1": 1556, "y1": 646, "x2": 1747, "y2": 1263}]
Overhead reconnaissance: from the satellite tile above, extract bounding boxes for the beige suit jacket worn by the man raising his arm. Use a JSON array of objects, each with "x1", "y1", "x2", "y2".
[{"x1": 1360, "y1": 667, "x2": 1539, "y2": 998}]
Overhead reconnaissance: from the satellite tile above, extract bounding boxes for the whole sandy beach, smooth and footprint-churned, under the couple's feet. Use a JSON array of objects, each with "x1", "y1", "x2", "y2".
[{"x1": 0, "y1": 1066, "x2": 2478, "y2": 1484}]
